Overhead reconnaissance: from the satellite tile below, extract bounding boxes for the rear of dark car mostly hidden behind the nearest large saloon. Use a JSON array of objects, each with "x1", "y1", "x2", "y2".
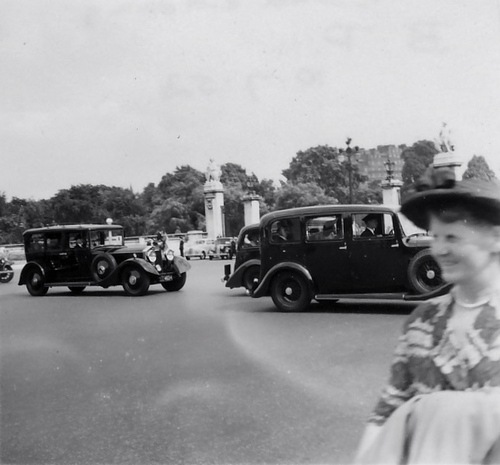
[{"x1": 223, "y1": 224, "x2": 260, "y2": 291}]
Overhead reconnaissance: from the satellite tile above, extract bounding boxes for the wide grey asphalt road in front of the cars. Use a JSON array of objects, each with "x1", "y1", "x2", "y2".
[{"x1": 0, "y1": 260, "x2": 411, "y2": 464}]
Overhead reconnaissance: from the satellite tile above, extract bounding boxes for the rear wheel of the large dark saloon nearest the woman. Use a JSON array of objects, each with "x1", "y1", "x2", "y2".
[{"x1": 271, "y1": 271, "x2": 312, "y2": 312}]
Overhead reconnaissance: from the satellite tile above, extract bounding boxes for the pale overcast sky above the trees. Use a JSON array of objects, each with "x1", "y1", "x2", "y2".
[{"x1": 0, "y1": 0, "x2": 500, "y2": 199}]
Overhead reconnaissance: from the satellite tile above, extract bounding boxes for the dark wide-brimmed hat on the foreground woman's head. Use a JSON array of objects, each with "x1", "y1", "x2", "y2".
[{"x1": 401, "y1": 168, "x2": 500, "y2": 229}]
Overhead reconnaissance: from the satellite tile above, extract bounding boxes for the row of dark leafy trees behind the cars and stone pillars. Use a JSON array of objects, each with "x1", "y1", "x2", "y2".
[{"x1": 0, "y1": 141, "x2": 495, "y2": 244}]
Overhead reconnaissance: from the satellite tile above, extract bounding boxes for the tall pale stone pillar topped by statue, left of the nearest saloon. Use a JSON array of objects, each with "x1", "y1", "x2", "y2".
[{"x1": 203, "y1": 158, "x2": 225, "y2": 239}]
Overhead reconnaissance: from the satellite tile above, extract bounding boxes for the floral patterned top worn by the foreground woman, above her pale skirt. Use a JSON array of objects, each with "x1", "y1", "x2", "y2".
[{"x1": 369, "y1": 290, "x2": 500, "y2": 425}]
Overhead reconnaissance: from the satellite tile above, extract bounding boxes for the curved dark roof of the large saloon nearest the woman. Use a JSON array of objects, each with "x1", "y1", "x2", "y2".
[{"x1": 260, "y1": 204, "x2": 396, "y2": 225}]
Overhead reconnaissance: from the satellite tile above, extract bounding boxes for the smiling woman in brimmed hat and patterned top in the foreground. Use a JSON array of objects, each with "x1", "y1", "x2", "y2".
[{"x1": 356, "y1": 170, "x2": 500, "y2": 464}]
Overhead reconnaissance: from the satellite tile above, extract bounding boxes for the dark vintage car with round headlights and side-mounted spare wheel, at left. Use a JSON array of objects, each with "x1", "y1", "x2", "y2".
[{"x1": 19, "y1": 224, "x2": 190, "y2": 296}]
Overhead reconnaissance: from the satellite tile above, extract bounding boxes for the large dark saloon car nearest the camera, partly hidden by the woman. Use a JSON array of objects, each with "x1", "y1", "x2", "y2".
[{"x1": 252, "y1": 205, "x2": 444, "y2": 311}]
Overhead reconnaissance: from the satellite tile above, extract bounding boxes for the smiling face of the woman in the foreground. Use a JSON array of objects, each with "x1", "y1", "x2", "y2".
[{"x1": 429, "y1": 216, "x2": 500, "y2": 284}]
